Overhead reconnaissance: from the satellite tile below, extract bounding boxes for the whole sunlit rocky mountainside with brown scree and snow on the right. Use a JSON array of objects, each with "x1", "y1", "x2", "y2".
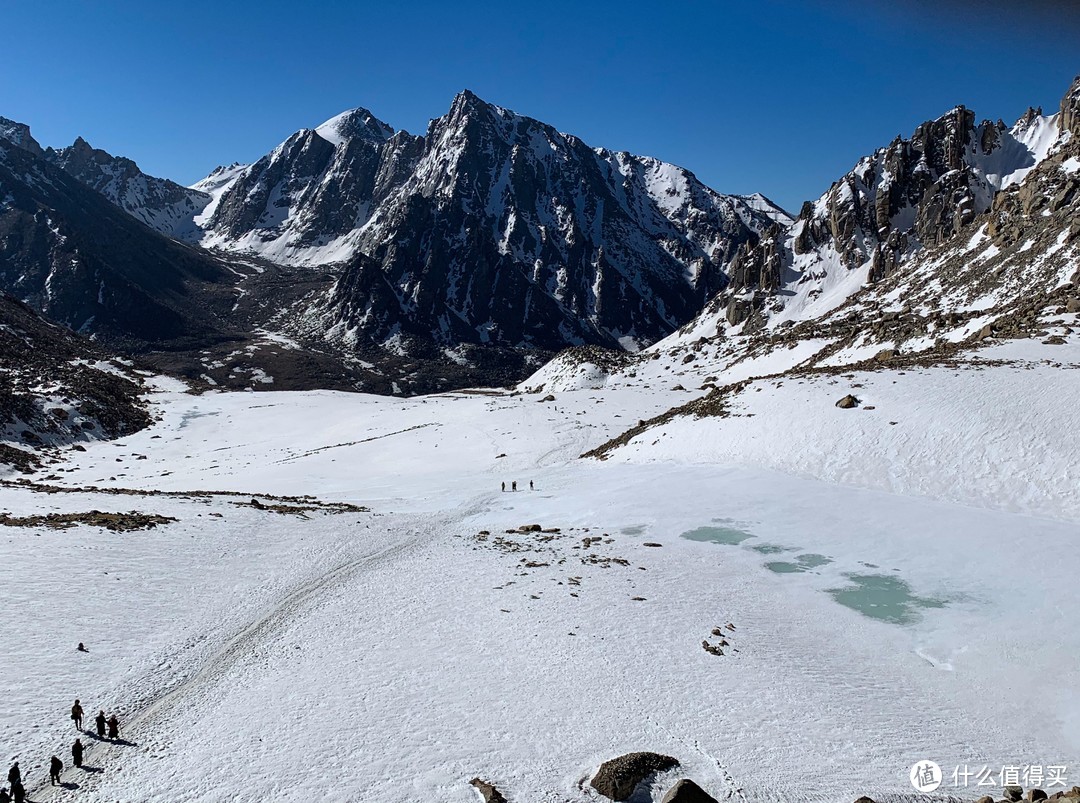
[{"x1": 523, "y1": 79, "x2": 1080, "y2": 401}]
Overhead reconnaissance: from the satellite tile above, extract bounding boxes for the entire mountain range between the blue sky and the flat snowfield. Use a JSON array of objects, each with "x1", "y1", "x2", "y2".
[{"x1": 0, "y1": 76, "x2": 1080, "y2": 410}]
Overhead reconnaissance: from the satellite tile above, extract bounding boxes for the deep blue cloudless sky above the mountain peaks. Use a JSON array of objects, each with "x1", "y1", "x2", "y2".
[{"x1": 0, "y1": 0, "x2": 1080, "y2": 212}]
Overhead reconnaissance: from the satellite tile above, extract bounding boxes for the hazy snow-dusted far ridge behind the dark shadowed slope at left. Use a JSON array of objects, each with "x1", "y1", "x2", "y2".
[{"x1": 42, "y1": 137, "x2": 210, "y2": 236}]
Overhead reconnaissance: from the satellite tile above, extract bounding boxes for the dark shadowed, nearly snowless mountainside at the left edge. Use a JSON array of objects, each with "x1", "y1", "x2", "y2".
[{"x1": 0, "y1": 137, "x2": 232, "y2": 348}]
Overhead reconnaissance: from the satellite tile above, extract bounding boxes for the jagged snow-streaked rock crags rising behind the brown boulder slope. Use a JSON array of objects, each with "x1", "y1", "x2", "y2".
[{"x1": 711, "y1": 100, "x2": 1062, "y2": 331}]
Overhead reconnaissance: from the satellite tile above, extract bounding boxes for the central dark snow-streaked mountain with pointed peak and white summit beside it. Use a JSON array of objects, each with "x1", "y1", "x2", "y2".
[{"x1": 198, "y1": 92, "x2": 789, "y2": 350}]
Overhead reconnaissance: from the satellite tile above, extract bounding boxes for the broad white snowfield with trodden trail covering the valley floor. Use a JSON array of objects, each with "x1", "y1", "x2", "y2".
[{"x1": 0, "y1": 338, "x2": 1080, "y2": 803}]
